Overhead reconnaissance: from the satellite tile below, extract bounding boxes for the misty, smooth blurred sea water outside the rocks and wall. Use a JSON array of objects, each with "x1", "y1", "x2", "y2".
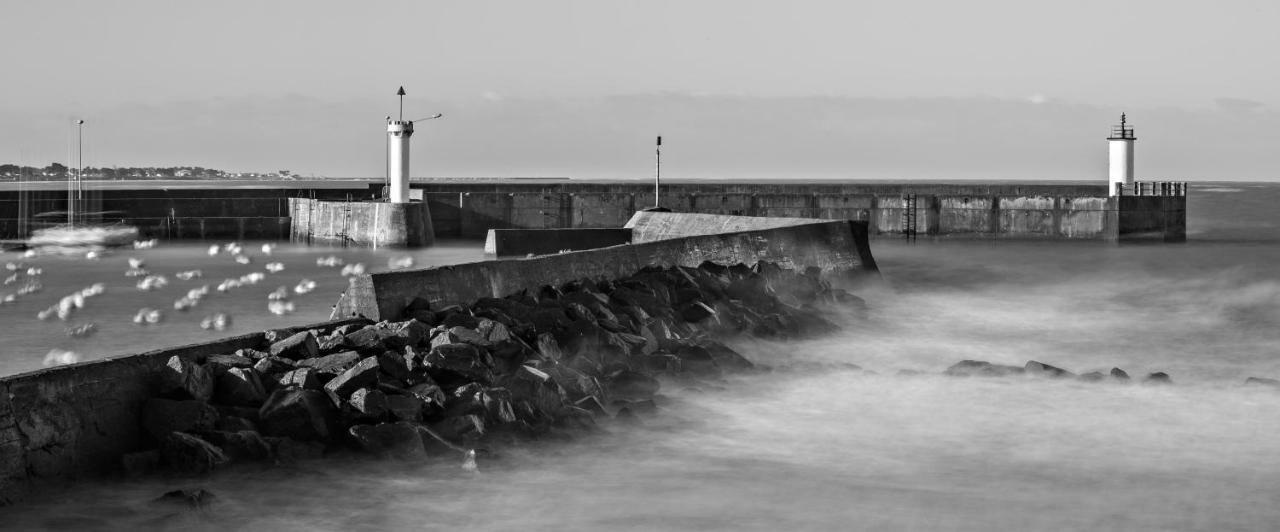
[{"x1": 0, "y1": 184, "x2": 1280, "y2": 531}]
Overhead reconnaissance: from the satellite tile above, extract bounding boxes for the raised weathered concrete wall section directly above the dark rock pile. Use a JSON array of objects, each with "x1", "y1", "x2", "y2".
[{"x1": 337, "y1": 220, "x2": 877, "y2": 320}]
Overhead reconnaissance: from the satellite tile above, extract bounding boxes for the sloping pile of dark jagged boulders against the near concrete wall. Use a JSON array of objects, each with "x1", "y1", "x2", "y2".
[{"x1": 123, "y1": 262, "x2": 863, "y2": 473}]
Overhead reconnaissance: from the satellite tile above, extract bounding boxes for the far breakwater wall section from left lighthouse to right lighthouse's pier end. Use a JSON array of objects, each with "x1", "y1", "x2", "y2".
[{"x1": 413, "y1": 182, "x2": 1185, "y2": 242}]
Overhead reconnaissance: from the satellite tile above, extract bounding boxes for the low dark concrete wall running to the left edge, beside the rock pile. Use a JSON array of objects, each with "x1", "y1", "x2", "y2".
[{"x1": 0, "y1": 320, "x2": 362, "y2": 504}]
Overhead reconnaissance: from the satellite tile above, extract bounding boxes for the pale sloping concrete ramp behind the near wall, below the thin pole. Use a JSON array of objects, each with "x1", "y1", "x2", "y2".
[{"x1": 625, "y1": 211, "x2": 831, "y2": 244}]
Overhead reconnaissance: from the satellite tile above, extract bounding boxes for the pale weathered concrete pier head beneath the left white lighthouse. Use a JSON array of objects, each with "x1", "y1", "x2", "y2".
[{"x1": 289, "y1": 198, "x2": 435, "y2": 248}]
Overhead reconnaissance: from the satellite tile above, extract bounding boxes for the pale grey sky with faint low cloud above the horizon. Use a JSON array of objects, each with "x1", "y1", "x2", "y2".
[{"x1": 0, "y1": 0, "x2": 1280, "y2": 180}]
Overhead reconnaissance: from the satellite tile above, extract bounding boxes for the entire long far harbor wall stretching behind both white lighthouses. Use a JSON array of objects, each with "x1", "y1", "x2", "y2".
[{"x1": 0, "y1": 179, "x2": 1185, "y2": 242}]
